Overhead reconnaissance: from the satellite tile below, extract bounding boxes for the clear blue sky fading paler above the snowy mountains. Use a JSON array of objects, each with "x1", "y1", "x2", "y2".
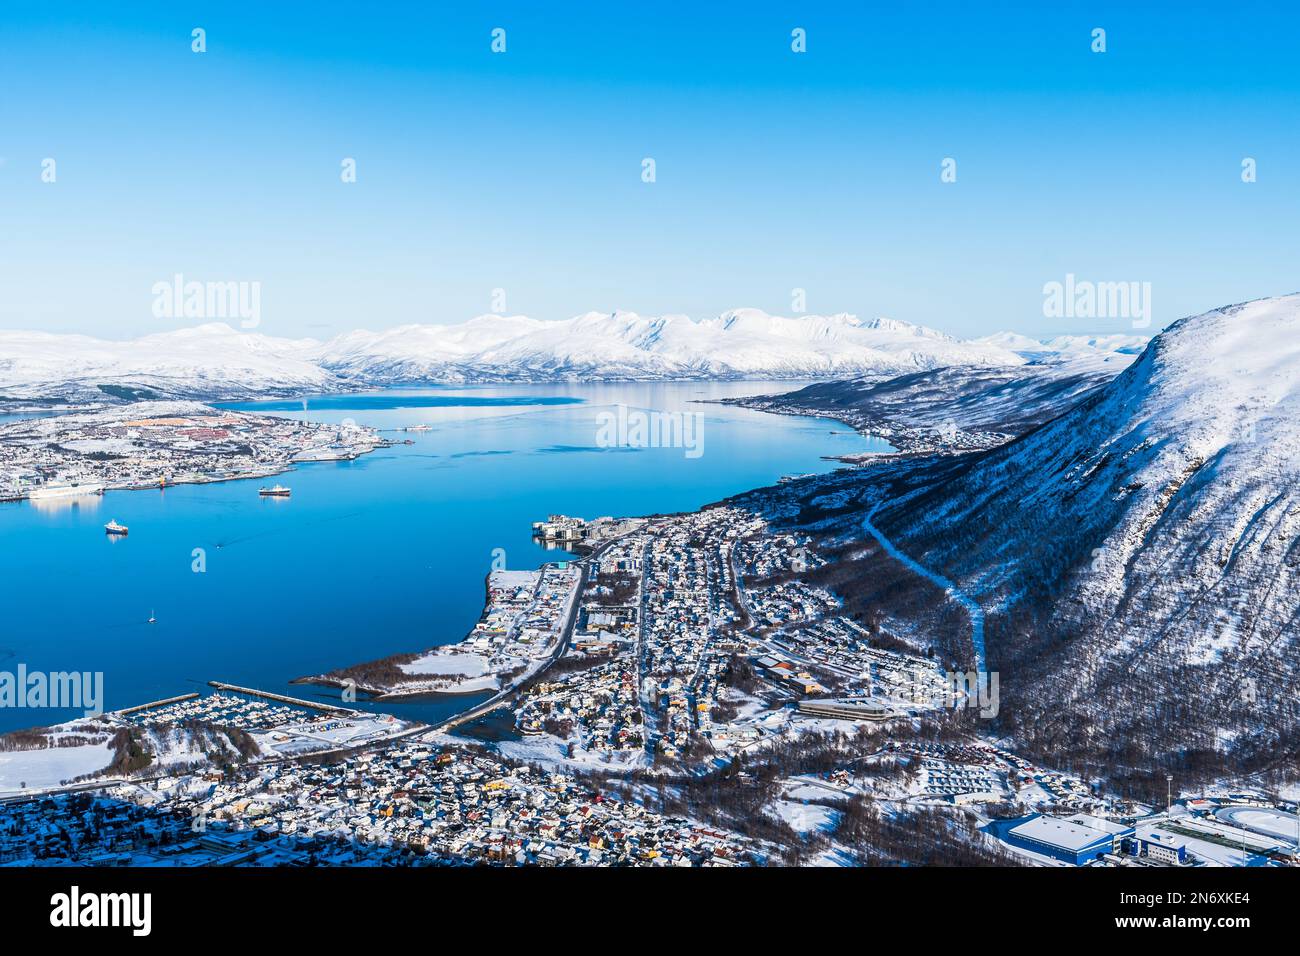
[{"x1": 0, "y1": 1, "x2": 1300, "y2": 338}]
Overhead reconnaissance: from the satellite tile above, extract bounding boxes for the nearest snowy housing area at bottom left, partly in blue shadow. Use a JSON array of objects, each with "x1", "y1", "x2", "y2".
[{"x1": 0, "y1": 691, "x2": 762, "y2": 866}]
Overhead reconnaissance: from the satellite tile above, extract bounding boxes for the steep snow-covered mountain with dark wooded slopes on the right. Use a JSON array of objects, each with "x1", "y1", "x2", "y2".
[{"x1": 874, "y1": 295, "x2": 1300, "y2": 765}]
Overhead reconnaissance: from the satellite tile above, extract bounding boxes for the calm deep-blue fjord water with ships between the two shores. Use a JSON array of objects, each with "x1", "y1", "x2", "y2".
[{"x1": 0, "y1": 382, "x2": 888, "y2": 731}]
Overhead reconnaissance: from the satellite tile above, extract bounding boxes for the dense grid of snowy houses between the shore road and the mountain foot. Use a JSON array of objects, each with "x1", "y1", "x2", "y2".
[{"x1": 504, "y1": 507, "x2": 953, "y2": 765}]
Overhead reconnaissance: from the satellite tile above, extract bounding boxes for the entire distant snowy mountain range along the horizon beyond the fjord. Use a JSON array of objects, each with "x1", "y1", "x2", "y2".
[{"x1": 0, "y1": 308, "x2": 1134, "y2": 401}]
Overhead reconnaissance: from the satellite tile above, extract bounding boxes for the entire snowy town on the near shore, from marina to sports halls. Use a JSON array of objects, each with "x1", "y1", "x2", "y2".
[{"x1": 0, "y1": 505, "x2": 1297, "y2": 868}]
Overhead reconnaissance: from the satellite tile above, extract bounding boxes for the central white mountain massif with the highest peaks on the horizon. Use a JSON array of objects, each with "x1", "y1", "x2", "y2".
[{"x1": 309, "y1": 308, "x2": 1024, "y2": 384}]
